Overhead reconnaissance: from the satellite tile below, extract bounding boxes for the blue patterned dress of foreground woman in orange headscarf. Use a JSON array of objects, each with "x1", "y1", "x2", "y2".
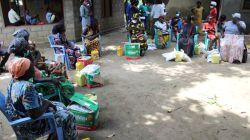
[{"x1": 6, "y1": 80, "x2": 77, "y2": 140}]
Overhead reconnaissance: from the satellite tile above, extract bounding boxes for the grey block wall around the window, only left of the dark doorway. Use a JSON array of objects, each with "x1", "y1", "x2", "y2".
[{"x1": 0, "y1": 0, "x2": 77, "y2": 45}]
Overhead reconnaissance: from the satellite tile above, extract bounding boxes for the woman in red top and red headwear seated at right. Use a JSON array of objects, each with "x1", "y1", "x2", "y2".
[{"x1": 203, "y1": 17, "x2": 218, "y2": 50}]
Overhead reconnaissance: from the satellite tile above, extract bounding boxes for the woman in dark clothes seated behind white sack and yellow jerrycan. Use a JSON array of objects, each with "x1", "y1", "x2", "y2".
[{"x1": 178, "y1": 16, "x2": 197, "y2": 57}]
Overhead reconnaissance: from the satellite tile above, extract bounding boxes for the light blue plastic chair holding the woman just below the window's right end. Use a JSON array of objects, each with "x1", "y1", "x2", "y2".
[{"x1": 48, "y1": 35, "x2": 71, "y2": 70}]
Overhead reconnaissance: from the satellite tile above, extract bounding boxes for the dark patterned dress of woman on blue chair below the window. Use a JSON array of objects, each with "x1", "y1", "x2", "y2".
[{"x1": 54, "y1": 33, "x2": 81, "y2": 67}]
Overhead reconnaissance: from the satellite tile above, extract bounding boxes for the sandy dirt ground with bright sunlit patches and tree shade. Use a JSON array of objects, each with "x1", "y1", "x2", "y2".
[{"x1": 0, "y1": 31, "x2": 250, "y2": 140}]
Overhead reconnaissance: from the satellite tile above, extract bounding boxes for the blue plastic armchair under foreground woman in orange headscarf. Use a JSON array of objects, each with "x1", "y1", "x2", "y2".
[{"x1": 0, "y1": 92, "x2": 64, "y2": 140}]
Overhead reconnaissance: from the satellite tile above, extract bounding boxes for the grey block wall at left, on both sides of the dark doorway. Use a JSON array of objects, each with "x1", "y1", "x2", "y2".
[{"x1": 0, "y1": 0, "x2": 124, "y2": 45}]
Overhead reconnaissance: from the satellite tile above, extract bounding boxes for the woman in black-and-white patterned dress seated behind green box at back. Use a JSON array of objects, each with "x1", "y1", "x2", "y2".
[{"x1": 128, "y1": 13, "x2": 148, "y2": 56}]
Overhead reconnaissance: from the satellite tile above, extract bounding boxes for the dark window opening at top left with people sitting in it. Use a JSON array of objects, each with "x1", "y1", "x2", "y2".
[{"x1": 0, "y1": 0, "x2": 63, "y2": 26}]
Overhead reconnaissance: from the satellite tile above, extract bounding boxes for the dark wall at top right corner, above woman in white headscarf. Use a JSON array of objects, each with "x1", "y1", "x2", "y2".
[{"x1": 222, "y1": 0, "x2": 250, "y2": 33}]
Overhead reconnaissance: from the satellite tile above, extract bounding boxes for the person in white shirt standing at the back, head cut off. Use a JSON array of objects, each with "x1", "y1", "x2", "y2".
[{"x1": 151, "y1": 0, "x2": 167, "y2": 39}]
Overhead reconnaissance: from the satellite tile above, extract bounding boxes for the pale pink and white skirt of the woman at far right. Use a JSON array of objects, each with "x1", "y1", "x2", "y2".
[{"x1": 220, "y1": 34, "x2": 245, "y2": 63}]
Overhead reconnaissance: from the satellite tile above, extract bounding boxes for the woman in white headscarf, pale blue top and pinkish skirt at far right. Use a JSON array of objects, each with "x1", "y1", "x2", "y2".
[{"x1": 220, "y1": 13, "x2": 246, "y2": 63}]
